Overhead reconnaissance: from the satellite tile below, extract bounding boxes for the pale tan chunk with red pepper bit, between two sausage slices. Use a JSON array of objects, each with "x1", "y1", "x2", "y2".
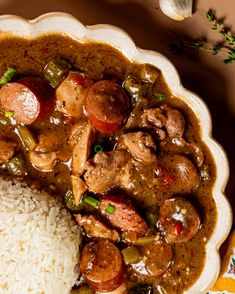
[{"x1": 56, "y1": 71, "x2": 93, "y2": 118}]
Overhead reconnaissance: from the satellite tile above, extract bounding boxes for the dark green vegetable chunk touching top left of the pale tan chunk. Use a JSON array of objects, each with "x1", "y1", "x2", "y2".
[{"x1": 43, "y1": 59, "x2": 72, "y2": 88}]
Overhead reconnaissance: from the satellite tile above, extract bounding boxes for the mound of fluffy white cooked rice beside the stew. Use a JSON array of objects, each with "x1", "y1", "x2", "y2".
[{"x1": 0, "y1": 179, "x2": 80, "y2": 294}]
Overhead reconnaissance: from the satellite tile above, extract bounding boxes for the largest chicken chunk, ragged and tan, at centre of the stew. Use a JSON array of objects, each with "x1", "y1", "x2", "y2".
[{"x1": 84, "y1": 150, "x2": 131, "y2": 193}]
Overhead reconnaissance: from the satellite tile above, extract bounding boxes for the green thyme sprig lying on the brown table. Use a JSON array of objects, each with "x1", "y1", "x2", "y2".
[{"x1": 170, "y1": 9, "x2": 235, "y2": 64}]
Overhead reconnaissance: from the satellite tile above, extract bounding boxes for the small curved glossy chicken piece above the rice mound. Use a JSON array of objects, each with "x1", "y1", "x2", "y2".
[{"x1": 29, "y1": 149, "x2": 71, "y2": 172}]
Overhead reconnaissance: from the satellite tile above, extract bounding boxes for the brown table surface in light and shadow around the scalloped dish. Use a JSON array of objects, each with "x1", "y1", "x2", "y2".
[{"x1": 0, "y1": 0, "x2": 235, "y2": 223}]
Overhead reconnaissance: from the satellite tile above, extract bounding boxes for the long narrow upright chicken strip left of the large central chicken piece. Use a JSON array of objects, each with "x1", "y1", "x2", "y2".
[{"x1": 71, "y1": 123, "x2": 93, "y2": 176}]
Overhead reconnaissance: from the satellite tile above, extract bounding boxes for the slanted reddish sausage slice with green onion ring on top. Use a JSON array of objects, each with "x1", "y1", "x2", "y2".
[{"x1": 99, "y1": 194, "x2": 148, "y2": 236}]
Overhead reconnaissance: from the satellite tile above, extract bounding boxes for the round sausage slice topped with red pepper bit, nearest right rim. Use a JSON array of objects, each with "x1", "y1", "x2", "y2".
[{"x1": 158, "y1": 197, "x2": 200, "y2": 243}]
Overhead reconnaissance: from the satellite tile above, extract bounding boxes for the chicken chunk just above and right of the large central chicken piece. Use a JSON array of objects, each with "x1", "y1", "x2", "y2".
[{"x1": 118, "y1": 132, "x2": 156, "y2": 164}]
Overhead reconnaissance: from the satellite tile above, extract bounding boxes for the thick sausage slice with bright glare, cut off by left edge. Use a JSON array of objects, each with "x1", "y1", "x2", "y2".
[{"x1": 0, "y1": 77, "x2": 55, "y2": 125}]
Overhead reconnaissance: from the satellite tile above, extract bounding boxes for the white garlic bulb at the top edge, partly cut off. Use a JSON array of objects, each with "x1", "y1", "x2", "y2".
[{"x1": 159, "y1": 0, "x2": 193, "y2": 20}]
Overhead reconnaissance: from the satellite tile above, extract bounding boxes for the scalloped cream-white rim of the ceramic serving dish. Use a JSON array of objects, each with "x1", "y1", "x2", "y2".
[{"x1": 0, "y1": 13, "x2": 232, "y2": 294}]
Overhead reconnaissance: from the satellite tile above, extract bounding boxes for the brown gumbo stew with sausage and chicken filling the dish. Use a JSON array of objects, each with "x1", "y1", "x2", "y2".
[{"x1": 0, "y1": 35, "x2": 216, "y2": 294}]
